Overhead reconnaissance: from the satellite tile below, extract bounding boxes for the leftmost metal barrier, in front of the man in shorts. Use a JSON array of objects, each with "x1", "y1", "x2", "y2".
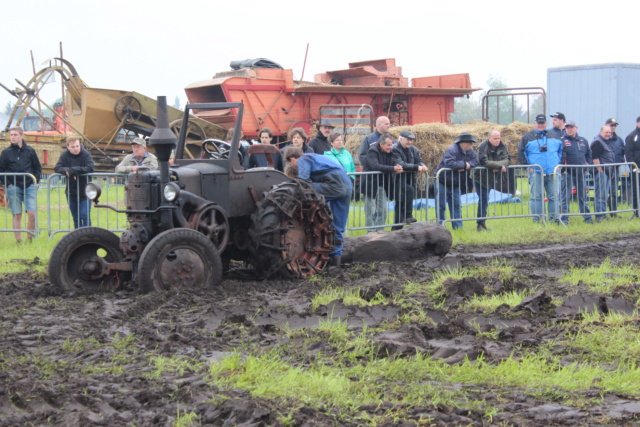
[{"x1": 0, "y1": 173, "x2": 40, "y2": 240}]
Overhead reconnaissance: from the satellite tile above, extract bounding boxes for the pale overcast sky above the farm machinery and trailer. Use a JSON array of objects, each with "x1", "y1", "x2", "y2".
[{"x1": 0, "y1": 0, "x2": 640, "y2": 114}]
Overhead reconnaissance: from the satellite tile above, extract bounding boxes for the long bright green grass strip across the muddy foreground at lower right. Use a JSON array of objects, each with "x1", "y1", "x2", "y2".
[{"x1": 209, "y1": 352, "x2": 640, "y2": 417}]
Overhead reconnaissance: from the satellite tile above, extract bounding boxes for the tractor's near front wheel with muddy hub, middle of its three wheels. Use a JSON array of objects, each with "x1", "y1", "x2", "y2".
[{"x1": 136, "y1": 228, "x2": 222, "y2": 292}]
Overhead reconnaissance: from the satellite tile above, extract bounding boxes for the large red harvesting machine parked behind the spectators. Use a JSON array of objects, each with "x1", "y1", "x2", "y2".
[{"x1": 185, "y1": 59, "x2": 479, "y2": 141}]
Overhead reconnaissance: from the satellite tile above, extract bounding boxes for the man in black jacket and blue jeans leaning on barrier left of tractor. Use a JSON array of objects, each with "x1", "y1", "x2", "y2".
[{"x1": 54, "y1": 136, "x2": 94, "y2": 228}]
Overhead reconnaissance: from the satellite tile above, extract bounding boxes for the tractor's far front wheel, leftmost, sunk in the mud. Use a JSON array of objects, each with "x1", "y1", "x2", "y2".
[{"x1": 49, "y1": 227, "x2": 130, "y2": 292}]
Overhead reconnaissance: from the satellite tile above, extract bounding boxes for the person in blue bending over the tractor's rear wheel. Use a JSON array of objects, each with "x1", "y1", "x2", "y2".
[{"x1": 284, "y1": 146, "x2": 352, "y2": 267}]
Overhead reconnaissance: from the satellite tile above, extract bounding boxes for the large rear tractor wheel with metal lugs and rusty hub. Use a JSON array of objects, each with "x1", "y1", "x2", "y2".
[{"x1": 249, "y1": 180, "x2": 335, "y2": 278}]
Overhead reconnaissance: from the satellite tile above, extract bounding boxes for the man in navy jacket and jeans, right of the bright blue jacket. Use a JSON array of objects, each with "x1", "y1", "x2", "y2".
[{"x1": 560, "y1": 120, "x2": 593, "y2": 225}]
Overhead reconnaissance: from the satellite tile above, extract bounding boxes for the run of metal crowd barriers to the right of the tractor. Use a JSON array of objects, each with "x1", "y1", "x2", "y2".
[{"x1": 347, "y1": 163, "x2": 640, "y2": 231}]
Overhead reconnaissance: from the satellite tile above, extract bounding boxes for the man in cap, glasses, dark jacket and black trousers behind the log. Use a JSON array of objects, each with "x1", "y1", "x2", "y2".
[{"x1": 391, "y1": 130, "x2": 427, "y2": 230}]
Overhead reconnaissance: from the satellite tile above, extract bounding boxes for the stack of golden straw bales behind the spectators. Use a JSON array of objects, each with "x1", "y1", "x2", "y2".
[{"x1": 346, "y1": 120, "x2": 533, "y2": 173}]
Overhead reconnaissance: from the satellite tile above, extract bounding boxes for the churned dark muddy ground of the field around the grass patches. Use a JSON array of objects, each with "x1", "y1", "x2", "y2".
[{"x1": 0, "y1": 235, "x2": 640, "y2": 426}]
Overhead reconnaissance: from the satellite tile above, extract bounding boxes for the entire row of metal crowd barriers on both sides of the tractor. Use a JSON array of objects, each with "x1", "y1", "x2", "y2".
[{"x1": 0, "y1": 163, "x2": 640, "y2": 237}]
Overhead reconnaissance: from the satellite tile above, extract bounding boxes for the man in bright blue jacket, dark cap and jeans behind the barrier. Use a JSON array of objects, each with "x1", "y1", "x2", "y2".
[{"x1": 518, "y1": 114, "x2": 562, "y2": 226}]
